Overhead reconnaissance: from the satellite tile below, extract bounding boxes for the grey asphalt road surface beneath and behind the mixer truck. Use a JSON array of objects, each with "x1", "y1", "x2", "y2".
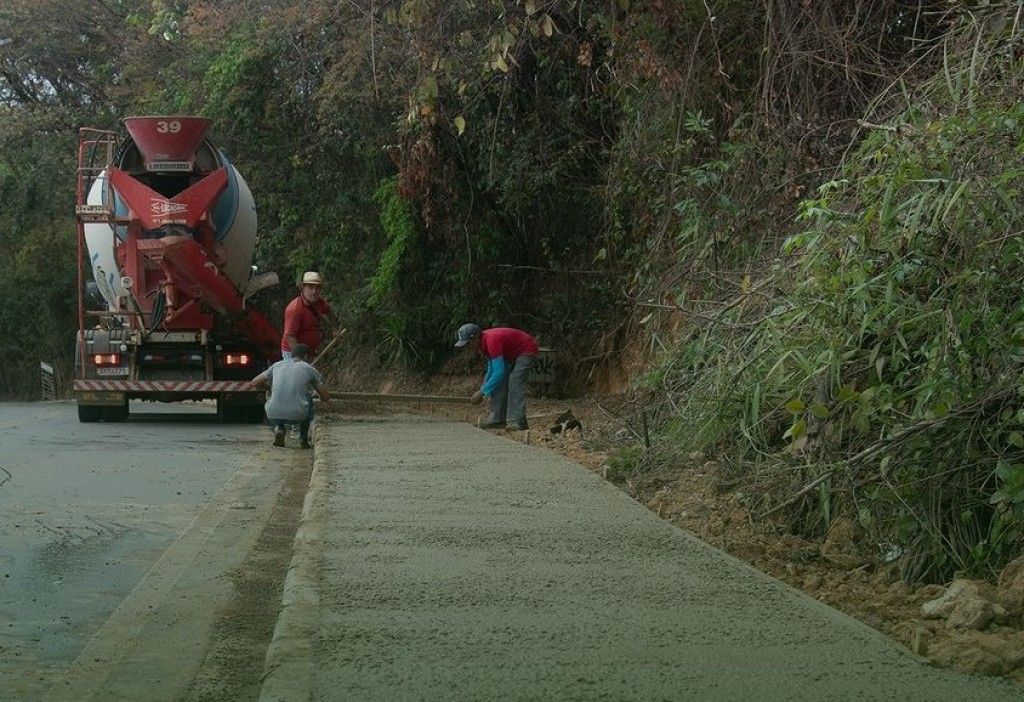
[{"x1": 0, "y1": 402, "x2": 300, "y2": 700}]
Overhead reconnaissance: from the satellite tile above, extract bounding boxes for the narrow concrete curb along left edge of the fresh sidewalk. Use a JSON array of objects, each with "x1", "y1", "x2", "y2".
[{"x1": 259, "y1": 425, "x2": 334, "y2": 702}]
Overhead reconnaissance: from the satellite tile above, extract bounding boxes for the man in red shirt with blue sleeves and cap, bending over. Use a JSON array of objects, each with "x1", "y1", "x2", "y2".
[{"x1": 455, "y1": 322, "x2": 539, "y2": 431}]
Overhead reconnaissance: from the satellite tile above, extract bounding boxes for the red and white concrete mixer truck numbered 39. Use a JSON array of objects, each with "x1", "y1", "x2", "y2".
[{"x1": 74, "y1": 116, "x2": 281, "y2": 422}]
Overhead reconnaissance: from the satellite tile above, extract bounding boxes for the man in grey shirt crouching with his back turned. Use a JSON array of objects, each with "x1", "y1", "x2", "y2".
[{"x1": 252, "y1": 344, "x2": 331, "y2": 448}]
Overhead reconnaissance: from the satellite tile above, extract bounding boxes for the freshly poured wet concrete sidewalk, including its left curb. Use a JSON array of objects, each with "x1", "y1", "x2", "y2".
[{"x1": 261, "y1": 419, "x2": 1022, "y2": 700}]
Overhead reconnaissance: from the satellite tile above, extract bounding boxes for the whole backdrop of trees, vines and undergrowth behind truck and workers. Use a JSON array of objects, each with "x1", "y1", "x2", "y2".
[{"x1": 0, "y1": 0, "x2": 1024, "y2": 579}]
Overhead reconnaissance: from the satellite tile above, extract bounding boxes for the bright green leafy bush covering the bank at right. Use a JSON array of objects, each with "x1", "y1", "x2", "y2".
[{"x1": 634, "y1": 10, "x2": 1024, "y2": 579}]
